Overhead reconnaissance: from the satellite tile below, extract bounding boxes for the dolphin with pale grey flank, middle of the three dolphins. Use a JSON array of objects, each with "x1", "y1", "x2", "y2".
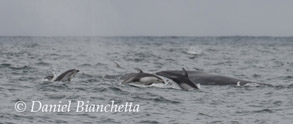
[{"x1": 121, "y1": 68, "x2": 164, "y2": 85}]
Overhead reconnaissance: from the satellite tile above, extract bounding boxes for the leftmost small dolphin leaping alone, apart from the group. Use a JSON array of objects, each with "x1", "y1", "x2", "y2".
[{"x1": 44, "y1": 69, "x2": 79, "y2": 82}]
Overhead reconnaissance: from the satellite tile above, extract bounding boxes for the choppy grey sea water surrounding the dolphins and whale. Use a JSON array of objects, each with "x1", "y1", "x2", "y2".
[{"x1": 0, "y1": 37, "x2": 293, "y2": 124}]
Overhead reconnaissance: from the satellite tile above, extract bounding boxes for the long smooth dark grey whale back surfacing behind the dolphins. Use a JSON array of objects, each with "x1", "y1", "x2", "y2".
[{"x1": 156, "y1": 70, "x2": 270, "y2": 86}]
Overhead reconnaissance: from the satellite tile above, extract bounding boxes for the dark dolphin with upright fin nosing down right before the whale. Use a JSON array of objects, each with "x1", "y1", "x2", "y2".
[{"x1": 156, "y1": 68, "x2": 199, "y2": 90}]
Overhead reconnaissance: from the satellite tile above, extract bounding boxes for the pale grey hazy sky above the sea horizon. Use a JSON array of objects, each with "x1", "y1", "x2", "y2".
[{"x1": 0, "y1": 0, "x2": 293, "y2": 36}]
